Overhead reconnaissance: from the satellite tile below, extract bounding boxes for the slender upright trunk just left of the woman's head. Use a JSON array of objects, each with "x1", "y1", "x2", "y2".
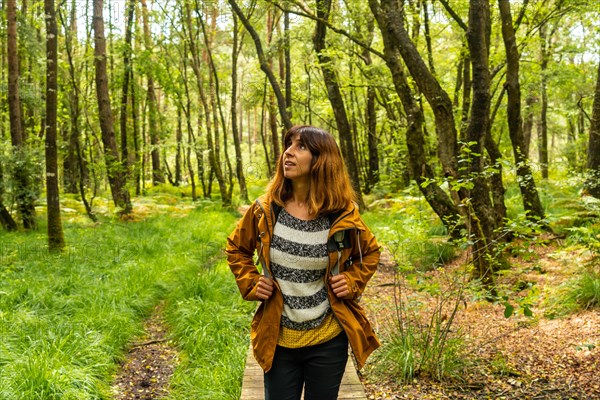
[{"x1": 231, "y1": 14, "x2": 250, "y2": 203}]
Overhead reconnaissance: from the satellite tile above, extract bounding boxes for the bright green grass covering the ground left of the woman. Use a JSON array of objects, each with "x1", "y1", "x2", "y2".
[{"x1": 0, "y1": 202, "x2": 250, "y2": 400}]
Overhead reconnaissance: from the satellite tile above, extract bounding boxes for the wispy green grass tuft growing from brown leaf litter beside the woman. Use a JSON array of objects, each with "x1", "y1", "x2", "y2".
[{"x1": 375, "y1": 275, "x2": 470, "y2": 382}]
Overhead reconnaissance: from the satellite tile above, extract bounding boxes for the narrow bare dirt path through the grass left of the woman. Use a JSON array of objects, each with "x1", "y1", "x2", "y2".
[{"x1": 113, "y1": 305, "x2": 179, "y2": 400}]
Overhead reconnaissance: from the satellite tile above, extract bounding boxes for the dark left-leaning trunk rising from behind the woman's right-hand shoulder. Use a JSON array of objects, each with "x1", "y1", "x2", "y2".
[{"x1": 313, "y1": 0, "x2": 364, "y2": 208}]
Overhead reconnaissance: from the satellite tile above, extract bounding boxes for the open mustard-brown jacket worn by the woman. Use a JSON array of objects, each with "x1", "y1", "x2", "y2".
[{"x1": 226, "y1": 195, "x2": 380, "y2": 372}]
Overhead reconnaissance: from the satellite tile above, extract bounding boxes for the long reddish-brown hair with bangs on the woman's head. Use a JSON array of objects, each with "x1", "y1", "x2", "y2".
[{"x1": 267, "y1": 125, "x2": 356, "y2": 216}]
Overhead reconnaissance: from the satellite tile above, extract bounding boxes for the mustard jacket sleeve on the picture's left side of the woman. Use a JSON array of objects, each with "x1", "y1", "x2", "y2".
[{"x1": 225, "y1": 206, "x2": 260, "y2": 300}]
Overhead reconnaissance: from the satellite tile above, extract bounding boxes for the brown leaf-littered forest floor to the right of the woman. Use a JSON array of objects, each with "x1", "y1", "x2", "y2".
[{"x1": 362, "y1": 239, "x2": 600, "y2": 400}]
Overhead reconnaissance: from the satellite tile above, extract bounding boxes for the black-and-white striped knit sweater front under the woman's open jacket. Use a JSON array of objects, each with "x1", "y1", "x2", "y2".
[{"x1": 271, "y1": 209, "x2": 330, "y2": 330}]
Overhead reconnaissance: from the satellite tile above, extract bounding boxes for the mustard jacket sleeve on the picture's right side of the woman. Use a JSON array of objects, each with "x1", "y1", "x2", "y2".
[{"x1": 343, "y1": 219, "x2": 381, "y2": 300}]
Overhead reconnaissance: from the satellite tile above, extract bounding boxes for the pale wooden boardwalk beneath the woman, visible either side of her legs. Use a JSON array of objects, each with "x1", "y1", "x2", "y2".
[{"x1": 240, "y1": 348, "x2": 367, "y2": 400}]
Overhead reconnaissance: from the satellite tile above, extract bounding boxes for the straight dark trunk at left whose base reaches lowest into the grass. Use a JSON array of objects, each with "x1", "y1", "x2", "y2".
[{"x1": 44, "y1": 0, "x2": 65, "y2": 251}]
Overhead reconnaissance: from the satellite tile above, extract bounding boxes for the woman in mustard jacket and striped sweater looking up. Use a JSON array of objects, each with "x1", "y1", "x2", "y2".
[{"x1": 227, "y1": 126, "x2": 379, "y2": 400}]
